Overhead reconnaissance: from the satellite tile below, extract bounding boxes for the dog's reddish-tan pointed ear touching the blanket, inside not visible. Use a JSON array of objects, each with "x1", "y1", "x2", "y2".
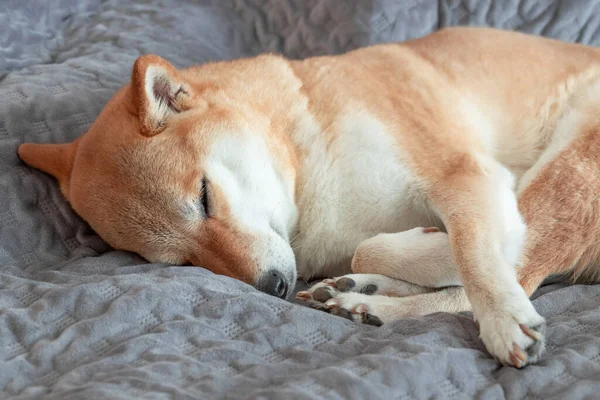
[{"x1": 18, "y1": 140, "x2": 78, "y2": 199}]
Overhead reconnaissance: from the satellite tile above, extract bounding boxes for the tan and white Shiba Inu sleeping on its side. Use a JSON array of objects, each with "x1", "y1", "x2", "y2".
[{"x1": 19, "y1": 28, "x2": 600, "y2": 367}]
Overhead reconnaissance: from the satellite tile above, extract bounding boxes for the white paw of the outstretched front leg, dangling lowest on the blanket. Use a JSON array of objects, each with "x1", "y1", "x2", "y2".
[{"x1": 478, "y1": 310, "x2": 546, "y2": 368}]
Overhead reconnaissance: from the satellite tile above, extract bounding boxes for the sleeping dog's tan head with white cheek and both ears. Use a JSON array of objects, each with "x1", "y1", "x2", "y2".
[{"x1": 19, "y1": 55, "x2": 297, "y2": 297}]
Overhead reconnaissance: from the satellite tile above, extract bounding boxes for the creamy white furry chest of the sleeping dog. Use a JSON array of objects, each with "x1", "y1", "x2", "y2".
[{"x1": 294, "y1": 112, "x2": 437, "y2": 276}]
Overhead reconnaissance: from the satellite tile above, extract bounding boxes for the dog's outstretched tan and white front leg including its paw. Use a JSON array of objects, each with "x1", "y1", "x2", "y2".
[{"x1": 430, "y1": 158, "x2": 545, "y2": 367}]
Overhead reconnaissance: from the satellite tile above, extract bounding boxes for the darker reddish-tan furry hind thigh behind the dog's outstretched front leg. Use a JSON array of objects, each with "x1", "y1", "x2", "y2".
[{"x1": 519, "y1": 117, "x2": 600, "y2": 295}]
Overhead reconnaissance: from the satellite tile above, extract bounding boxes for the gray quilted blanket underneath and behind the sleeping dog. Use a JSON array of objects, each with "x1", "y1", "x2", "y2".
[{"x1": 0, "y1": 0, "x2": 600, "y2": 399}]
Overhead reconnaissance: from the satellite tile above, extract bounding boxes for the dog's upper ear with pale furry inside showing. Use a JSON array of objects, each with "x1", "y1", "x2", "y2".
[{"x1": 131, "y1": 54, "x2": 190, "y2": 136}]
